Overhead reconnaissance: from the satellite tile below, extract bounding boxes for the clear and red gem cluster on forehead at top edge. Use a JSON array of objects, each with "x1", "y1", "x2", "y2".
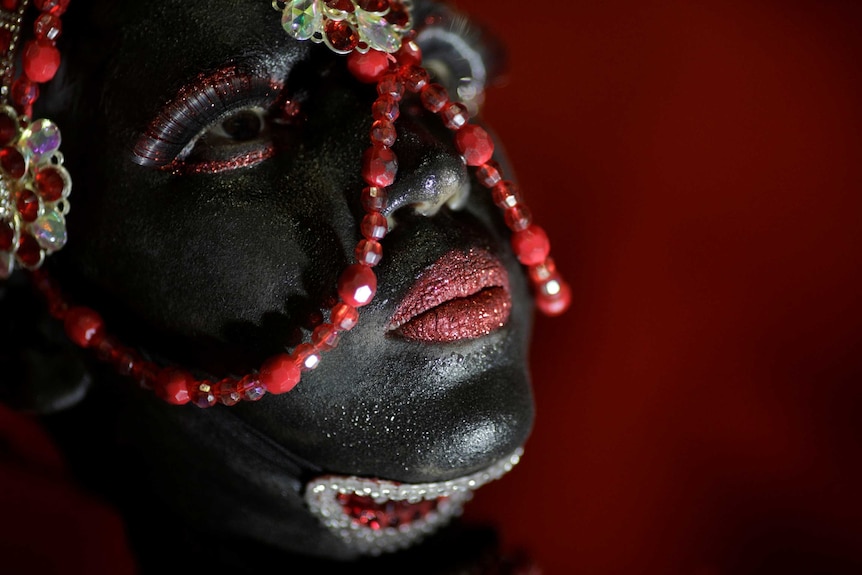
[{"x1": 273, "y1": 0, "x2": 413, "y2": 54}]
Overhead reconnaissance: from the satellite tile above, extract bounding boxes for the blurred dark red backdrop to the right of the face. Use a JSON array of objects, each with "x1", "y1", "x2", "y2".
[{"x1": 460, "y1": 0, "x2": 862, "y2": 575}]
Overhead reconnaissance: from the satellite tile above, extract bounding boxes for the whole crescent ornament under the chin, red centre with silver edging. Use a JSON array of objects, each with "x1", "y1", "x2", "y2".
[{"x1": 305, "y1": 449, "x2": 523, "y2": 555}]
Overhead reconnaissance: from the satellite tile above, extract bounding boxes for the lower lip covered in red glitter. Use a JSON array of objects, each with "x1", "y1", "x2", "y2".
[{"x1": 397, "y1": 286, "x2": 512, "y2": 343}]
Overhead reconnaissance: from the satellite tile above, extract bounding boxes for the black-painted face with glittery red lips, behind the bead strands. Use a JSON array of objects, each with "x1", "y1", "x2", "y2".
[{"x1": 43, "y1": 0, "x2": 533, "y2": 557}]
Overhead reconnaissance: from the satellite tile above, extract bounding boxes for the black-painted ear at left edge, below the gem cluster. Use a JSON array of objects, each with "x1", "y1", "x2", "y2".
[{"x1": 0, "y1": 271, "x2": 92, "y2": 414}]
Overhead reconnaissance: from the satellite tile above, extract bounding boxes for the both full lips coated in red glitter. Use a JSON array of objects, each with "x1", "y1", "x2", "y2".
[{"x1": 389, "y1": 249, "x2": 512, "y2": 343}]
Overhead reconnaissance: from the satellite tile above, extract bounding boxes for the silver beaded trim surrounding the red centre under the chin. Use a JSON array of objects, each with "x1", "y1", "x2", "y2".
[{"x1": 305, "y1": 448, "x2": 523, "y2": 555}]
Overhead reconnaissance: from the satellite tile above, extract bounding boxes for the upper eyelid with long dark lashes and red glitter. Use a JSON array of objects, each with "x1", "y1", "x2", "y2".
[{"x1": 132, "y1": 68, "x2": 283, "y2": 168}]
